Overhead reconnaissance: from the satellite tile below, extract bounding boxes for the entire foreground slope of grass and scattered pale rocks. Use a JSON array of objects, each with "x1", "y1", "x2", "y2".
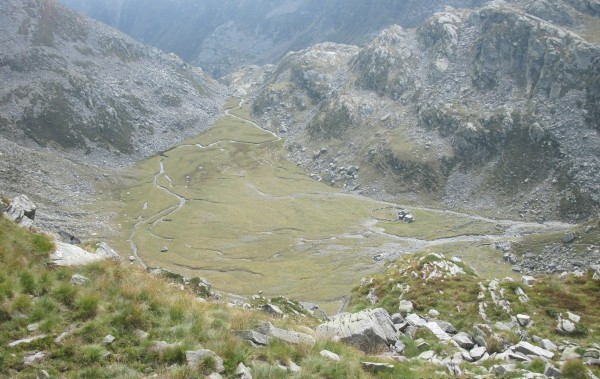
[{"x1": 0, "y1": 205, "x2": 600, "y2": 379}]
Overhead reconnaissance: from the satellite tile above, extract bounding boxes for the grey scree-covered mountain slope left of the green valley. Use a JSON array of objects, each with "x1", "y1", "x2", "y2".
[{"x1": 0, "y1": 0, "x2": 226, "y2": 235}]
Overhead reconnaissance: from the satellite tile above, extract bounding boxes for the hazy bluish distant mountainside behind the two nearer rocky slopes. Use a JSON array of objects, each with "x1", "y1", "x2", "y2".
[{"x1": 56, "y1": 0, "x2": 484, "y2": 76}]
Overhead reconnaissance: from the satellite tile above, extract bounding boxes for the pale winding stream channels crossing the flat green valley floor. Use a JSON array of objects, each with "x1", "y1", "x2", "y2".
[{"x1": 128, "y1": 99, "x2": 573, "y2": 269}]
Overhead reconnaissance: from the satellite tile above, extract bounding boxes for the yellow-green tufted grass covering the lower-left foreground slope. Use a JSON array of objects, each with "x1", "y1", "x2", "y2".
[{"x1": 0, "y1": 219, "x2": 450, "y2": 379}]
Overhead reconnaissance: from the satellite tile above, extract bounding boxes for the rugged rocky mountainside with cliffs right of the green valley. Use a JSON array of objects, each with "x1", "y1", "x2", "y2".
[{"x1": 236, "y1": 0, "x2": 600, "y2": 221}]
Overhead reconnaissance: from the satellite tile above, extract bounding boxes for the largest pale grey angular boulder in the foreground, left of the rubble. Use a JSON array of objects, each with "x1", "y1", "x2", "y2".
[{"x1": 317, "y1": 308, "x2": 398, "y2": 353}]
